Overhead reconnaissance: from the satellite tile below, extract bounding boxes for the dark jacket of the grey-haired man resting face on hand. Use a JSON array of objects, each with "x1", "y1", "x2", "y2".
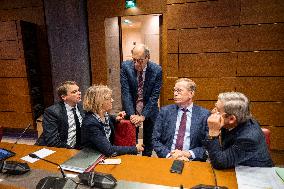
[{"x1": 204, "y1": 119, "x2": 273, "y2": 169}]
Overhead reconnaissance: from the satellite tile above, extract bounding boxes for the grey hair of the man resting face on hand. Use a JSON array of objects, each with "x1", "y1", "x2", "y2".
[{"x1": 218, "y1": 92, "x2": 252, "y2": 123}]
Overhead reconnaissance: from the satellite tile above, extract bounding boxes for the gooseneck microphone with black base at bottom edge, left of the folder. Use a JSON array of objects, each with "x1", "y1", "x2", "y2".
[{"x1": 29, "y1": 154, "x2": 78, "y2": 189}]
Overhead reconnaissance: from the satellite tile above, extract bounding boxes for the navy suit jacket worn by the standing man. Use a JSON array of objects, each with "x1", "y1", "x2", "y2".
[{"x1": 120, "y1": 60, "x2": 162, "y2": 121}]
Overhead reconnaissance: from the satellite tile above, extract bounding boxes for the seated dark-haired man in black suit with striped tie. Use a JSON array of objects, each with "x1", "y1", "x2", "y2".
[{"x1": 36, "y1": 81, "x2": 84, "y2": 149}]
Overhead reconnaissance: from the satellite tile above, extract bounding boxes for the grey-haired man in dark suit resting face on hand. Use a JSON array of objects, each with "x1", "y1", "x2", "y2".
[{"x1": 204, "y1": 92, "x2": 273, "y2": 169}]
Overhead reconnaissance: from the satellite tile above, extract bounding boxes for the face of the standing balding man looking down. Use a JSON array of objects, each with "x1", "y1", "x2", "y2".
[{"x1": 132, "y1": 49, "x2": 148, "y2": 71}]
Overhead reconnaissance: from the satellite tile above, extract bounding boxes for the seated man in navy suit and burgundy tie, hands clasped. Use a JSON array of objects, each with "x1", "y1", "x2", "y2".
[{"x1": 153, "y1": 78, "x2": 210, "y2": 161}]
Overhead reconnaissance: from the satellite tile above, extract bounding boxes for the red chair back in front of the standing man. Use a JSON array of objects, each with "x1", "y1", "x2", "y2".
[{"x1": 114, "y1": 120, "x2": 136, "y2": 146}]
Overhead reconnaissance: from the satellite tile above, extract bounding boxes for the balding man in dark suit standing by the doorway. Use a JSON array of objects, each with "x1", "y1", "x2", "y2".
[{"x1": 120, "y1": 44, "x2": 162, "y2": 156}]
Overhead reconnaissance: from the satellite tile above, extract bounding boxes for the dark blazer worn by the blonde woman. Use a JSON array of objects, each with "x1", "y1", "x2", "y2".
[{"x1": 81, "y1": 112, "x2": 137, "y2": 157}]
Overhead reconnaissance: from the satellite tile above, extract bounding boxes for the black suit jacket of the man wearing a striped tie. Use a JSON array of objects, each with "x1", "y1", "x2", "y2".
[{"x1": 36, "y1": 102, "x2": 84, "y2": 148}]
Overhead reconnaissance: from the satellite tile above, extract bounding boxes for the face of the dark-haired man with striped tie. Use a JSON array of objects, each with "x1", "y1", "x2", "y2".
[{"x1": 62, "y1": 85, "x2": 81, "y2": 107}]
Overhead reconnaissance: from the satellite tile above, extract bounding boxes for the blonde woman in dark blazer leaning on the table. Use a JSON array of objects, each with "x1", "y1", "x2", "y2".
[{"x1": 81, "y1": 85, "x2": 144, "y2": 157}]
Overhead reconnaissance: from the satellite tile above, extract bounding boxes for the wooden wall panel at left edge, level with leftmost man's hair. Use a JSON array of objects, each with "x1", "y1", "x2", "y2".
[{"x1": 0, "y1": 78, "x2": 29, "y2": 96}]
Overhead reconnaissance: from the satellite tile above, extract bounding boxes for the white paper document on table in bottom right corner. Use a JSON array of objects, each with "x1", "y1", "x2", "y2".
[{"x1": 235, "y1": 166, "x2": 284, "y2": 189}]
